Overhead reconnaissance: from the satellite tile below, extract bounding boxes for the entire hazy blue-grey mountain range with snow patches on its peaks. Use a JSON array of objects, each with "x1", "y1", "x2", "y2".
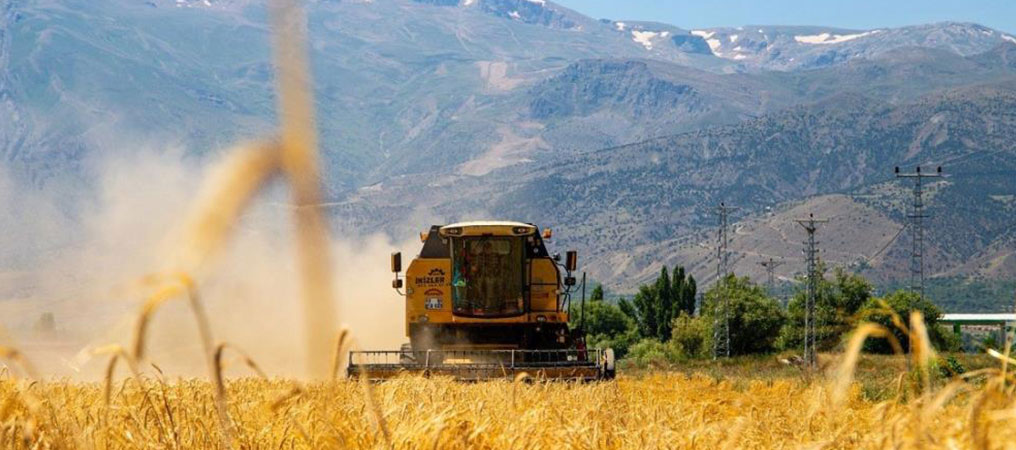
[{"x1": 0, "y1": 0, "x2": 1016, "y2": 309}]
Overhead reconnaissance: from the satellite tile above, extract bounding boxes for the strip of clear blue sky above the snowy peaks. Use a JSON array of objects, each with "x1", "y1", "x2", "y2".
[{"x1": 555, "y1": 0, "x2": 1016, "y2": 34}]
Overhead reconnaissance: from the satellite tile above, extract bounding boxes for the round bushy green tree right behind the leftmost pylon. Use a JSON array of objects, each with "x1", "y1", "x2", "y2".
[{"x1": 701, "y1": 275, "x2": 786, "y2": 355}]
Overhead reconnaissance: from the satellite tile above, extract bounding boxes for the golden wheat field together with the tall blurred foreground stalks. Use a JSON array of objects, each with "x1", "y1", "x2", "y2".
[{"x1": 0, "y1": 0, "x2": 1016, "y2": 449}]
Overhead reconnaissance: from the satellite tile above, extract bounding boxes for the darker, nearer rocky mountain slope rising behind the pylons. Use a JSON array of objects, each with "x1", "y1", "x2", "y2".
[{"x1": 339, "y1": 81, "x2": 1016, "y2": 296}]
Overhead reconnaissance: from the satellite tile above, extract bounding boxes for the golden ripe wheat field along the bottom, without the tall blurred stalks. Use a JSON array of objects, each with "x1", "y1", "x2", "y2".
[{"x1": 0, "y1": 361, "x2": 1016, "y2": 449}]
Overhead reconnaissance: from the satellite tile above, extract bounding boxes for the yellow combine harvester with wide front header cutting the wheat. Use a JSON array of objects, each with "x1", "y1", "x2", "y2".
[{"x1": 348, "y1": 221, "x2": 615, "y2": 380}]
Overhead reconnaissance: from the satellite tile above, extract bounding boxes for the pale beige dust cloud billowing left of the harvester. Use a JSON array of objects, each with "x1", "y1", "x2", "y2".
[{"x1": 0, "y1": 149, "x2": 418, "y2": 380}]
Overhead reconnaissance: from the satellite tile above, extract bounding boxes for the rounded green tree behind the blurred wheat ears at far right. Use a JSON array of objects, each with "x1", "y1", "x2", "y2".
[{"x1": 860, "y1": 291, "x2": 951, "y2": 353}]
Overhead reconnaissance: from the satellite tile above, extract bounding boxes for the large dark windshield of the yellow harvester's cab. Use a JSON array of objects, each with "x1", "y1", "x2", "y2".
[{"x1": 452, "y1": 237, "x2": 525, "y2": 316}]
